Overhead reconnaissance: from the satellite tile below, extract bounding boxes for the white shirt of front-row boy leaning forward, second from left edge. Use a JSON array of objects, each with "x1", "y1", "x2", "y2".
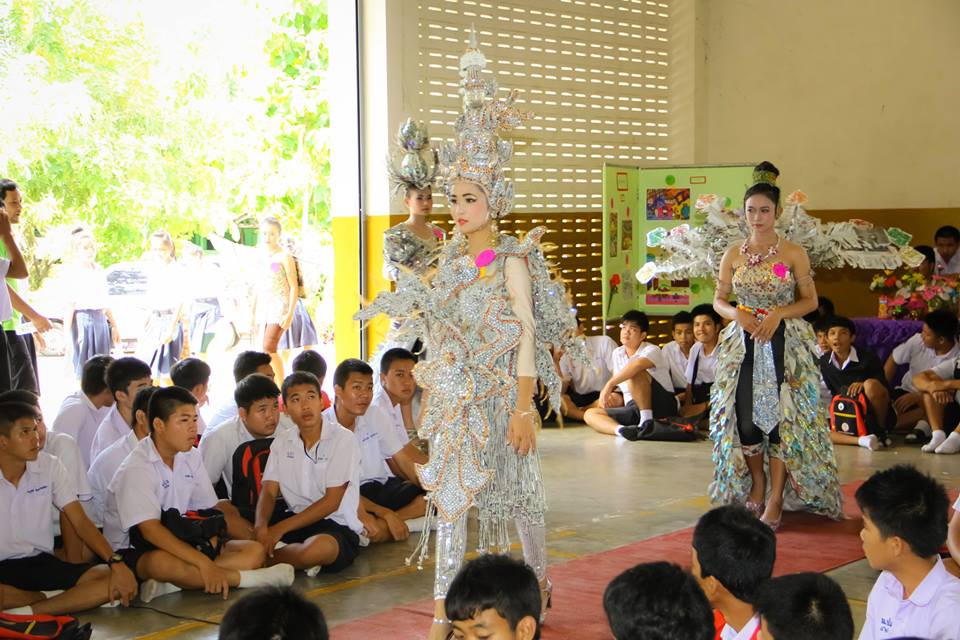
[{"x1": 103, "y1": 436, "x2": 217, "y2": 549}]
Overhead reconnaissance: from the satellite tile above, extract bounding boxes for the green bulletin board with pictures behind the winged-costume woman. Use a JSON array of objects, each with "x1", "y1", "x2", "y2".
[{"x1": 603, "y1": 164, "x2": 754, "y2": 322}]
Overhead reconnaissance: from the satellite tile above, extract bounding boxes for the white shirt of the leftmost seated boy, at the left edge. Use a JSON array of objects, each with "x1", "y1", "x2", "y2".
[{"x1": 0, "y1": 451, "x2": 77, "y2": 561}]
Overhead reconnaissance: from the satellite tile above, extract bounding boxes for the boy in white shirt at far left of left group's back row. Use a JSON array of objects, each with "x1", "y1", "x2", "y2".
[{"x1": 50, "y1": 356, "x2": 116, "y2": 468}]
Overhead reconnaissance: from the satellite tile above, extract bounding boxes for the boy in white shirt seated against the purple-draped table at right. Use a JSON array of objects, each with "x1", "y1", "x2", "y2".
[{"x1": 883, "y1": 309, "x2": 960, "y2": 442}]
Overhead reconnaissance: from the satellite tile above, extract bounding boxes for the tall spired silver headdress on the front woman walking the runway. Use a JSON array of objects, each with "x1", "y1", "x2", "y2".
[{"x1": 440, "y1": 28, "x2": 531, "y2": 219}]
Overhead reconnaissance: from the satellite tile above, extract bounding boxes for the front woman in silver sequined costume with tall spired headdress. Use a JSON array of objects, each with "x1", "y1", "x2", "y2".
[{"x1": 360, "y1": 34, "x2": 584, "y2": 639}]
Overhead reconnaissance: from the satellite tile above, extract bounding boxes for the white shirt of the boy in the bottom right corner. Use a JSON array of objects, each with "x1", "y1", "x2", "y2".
[{"x1": 860, "y1": 556, "x2": 960, "y2": 640}]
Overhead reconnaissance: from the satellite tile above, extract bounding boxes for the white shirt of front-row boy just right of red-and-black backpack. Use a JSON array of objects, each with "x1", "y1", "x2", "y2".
[{"x1": 263, "y1": 418, "x2": 363, "y2": 535}]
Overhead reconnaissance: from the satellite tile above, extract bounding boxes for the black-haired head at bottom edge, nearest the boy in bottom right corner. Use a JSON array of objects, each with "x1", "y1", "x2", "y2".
[{"x1": 756, "y1": 573, "x2": 852, "y2": 640}]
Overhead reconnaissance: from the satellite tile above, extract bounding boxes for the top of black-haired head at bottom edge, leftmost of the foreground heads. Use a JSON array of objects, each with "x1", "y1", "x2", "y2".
[{"x1": 217, "y1": 587, "x2": 330, "y2": 640}]
